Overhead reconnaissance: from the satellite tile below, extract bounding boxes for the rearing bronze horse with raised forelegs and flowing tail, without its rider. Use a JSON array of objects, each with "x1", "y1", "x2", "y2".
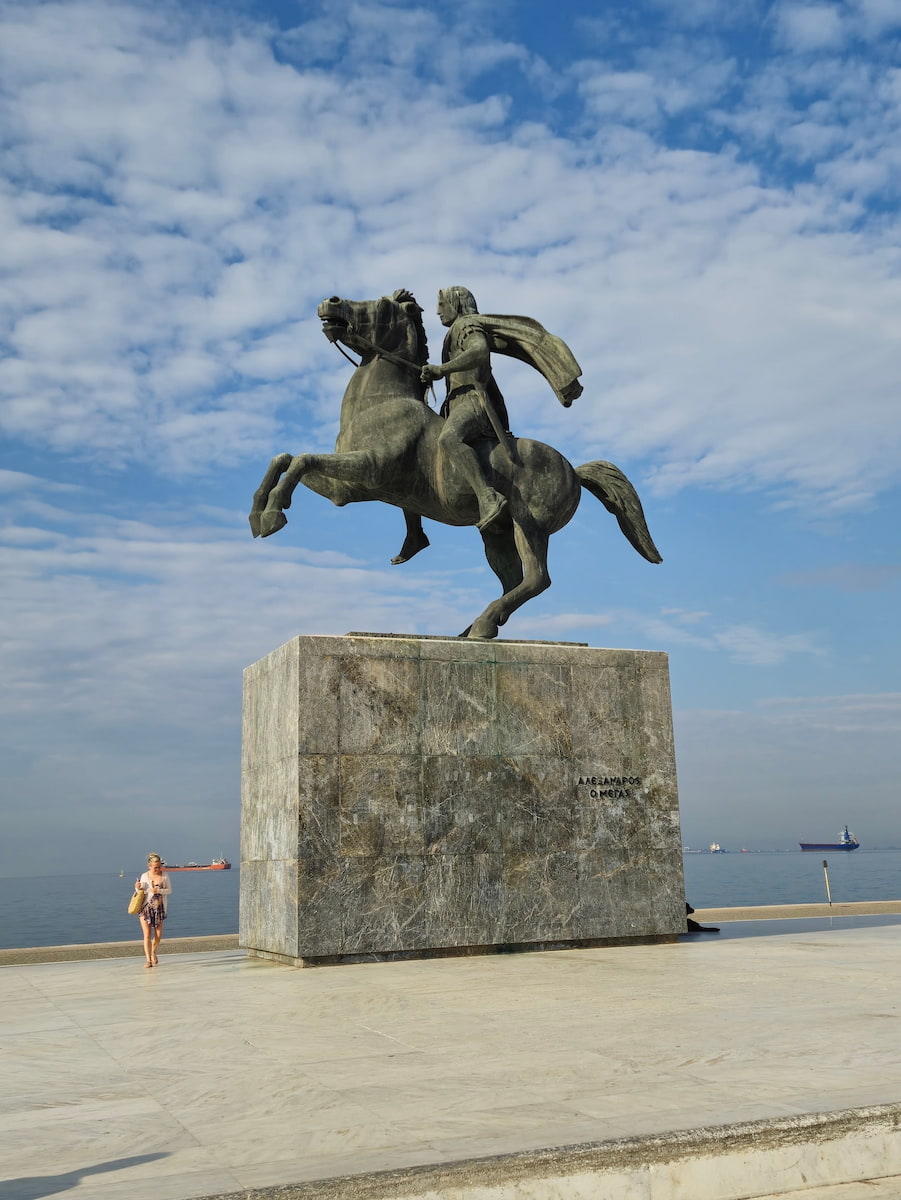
[{"x1": 250, "y1": 289, "x2": 662, "y2": 640}]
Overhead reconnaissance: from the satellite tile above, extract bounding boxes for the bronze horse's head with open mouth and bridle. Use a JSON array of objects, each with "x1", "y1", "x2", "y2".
[{"x1": 317, "y1": 288, "x2": 428, "y2": 366}]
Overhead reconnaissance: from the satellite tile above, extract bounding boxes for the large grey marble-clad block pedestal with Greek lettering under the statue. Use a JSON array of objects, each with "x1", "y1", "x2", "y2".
[{"x1": 240, "y1": 634, "x2": 685, "y2": 965}]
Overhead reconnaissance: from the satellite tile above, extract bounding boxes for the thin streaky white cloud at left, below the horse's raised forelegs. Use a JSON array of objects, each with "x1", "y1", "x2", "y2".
[{"x1": 0, "y1": 509, "x2": 477, "y2": 728}]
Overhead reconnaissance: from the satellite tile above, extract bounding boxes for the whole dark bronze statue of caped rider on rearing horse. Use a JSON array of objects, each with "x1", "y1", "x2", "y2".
[{"x1": 250, "y1": 287, "x2": 661, "y2": 638}]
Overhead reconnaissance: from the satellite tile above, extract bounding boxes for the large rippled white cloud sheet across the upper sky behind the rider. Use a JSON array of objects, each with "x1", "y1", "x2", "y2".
[{"x1": 0, "y1": 0, "x2": 901, "y2": 508}]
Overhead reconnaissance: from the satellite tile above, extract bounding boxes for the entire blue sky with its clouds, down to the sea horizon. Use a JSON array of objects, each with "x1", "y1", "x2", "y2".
[{"x1": 0, "y1": 0, "x2": 901, "y2": 875}]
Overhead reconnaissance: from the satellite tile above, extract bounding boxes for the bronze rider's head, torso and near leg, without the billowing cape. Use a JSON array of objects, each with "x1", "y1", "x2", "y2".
[{"x1": 421, "y1": 287, "x2": 509, "y2": 529}]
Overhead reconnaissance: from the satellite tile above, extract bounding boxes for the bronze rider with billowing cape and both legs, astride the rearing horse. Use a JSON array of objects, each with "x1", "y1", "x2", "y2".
[{"x1": 391, "y1": 286, "x2": 582, "y2": 563}]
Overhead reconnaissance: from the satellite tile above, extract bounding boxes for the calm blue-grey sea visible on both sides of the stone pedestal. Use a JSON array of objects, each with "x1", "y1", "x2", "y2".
[{"x1": 0, "y1": 850, "x2": 901, "y2": 949}]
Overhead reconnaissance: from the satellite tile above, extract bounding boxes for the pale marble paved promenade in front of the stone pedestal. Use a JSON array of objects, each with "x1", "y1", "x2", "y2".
[{"x1": 0, "y1": 925, "x2": 901, "y2": 1200}]
